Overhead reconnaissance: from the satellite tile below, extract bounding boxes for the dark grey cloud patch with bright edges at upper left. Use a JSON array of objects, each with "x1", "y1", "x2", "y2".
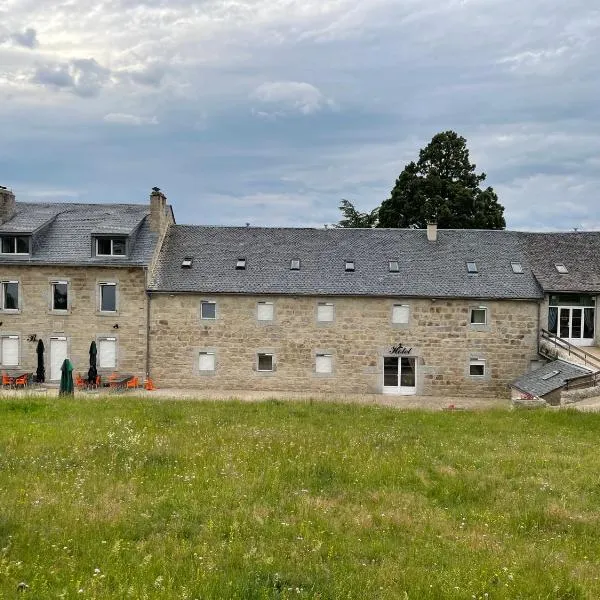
[{"x1": 31, "y1": 58, "x2": 110, "y2": 98}]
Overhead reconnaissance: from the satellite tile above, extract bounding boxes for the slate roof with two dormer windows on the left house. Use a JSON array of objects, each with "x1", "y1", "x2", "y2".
[{"x1": 0, "y1": 202, "x2": 157, "y2": 266}]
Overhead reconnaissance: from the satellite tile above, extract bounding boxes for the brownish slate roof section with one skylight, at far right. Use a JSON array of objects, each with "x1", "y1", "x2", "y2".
[{"x1": 525, "y1": 231, "x2": 600, "y2": 293}]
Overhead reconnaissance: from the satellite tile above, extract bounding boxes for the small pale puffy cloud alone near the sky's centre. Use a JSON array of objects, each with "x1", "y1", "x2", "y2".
[{"x1": 251, "y1": 81, "x2": 335, "y2": 117}]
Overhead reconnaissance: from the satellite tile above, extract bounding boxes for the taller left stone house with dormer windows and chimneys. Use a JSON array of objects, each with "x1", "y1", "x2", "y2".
[{"x1": 0, "y1": 188, "x2": 174, "y2": 382}]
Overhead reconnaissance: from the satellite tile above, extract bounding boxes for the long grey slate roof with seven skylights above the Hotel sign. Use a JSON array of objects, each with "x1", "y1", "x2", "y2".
[{"x1": 150, "y1": 225, "x2": 542, "y2": 299}]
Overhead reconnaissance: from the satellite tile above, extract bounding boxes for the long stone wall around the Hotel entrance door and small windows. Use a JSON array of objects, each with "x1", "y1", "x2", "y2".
[{"x1": 150, "y1": 294, "x2": 538, "y2": 397}]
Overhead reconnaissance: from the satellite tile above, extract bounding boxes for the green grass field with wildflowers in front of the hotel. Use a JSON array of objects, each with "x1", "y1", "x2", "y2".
[{"x1": 0, "y1": 398, "x2": 600, "y2": 600}]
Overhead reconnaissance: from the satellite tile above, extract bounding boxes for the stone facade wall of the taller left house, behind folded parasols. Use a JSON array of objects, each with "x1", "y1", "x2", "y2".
[{"x1": 0, "y1": 265, "x2": 146, "y2": 379}]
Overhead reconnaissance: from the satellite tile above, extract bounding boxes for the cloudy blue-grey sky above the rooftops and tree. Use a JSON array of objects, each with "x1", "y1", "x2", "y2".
[{"x1": 0, "y1": 0, "x2": 600, "y2": 230}]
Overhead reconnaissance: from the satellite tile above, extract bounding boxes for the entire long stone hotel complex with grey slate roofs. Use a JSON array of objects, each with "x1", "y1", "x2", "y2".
[{"x1": 0, "y1": 188, "x2": 600, "y2": 396}]
